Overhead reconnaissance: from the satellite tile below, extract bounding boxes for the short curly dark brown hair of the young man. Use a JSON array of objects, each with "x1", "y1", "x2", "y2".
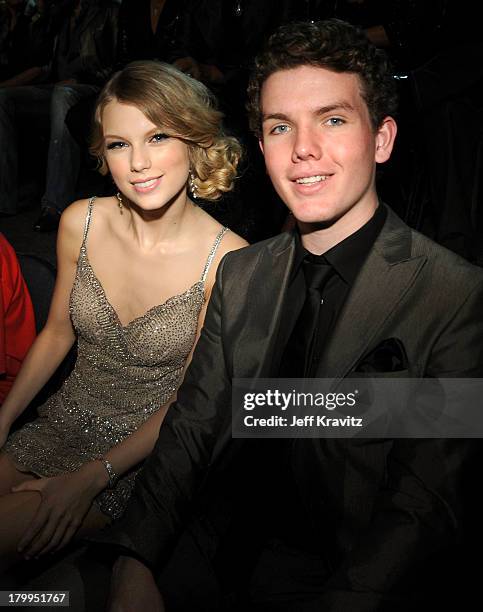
[{"x1": 247, "y1": 19, "x2": 397, "y2": 138}]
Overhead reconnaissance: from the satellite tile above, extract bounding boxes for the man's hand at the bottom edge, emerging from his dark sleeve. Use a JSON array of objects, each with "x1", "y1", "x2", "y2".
[{"x1": 107, "y1": 557, "x2": 165, "y2": 612}]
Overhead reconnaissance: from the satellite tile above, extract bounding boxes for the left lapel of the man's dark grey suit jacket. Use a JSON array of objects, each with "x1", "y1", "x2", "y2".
[{"x1": 233, "y1": 234, "x2": 295, "y2": 378}]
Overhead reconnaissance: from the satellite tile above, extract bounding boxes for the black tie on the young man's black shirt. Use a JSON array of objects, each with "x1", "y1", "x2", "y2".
[{"x1": 282, "y1": 255, "x2": 333, "y2": 378}]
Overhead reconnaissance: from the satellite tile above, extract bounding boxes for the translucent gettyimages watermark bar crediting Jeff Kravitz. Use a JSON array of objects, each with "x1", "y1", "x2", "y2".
[{"x1": 232, "y1": 377, "x2": 483, "y2": 438}]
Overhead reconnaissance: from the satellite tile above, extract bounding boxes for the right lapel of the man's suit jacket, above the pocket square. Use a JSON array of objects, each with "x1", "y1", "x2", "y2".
[{"x1": 317, "y1": 209, "x2": 426, "y2": 378}]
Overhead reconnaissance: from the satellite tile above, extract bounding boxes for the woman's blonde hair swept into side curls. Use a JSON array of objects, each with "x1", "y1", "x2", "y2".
[{"x1": 90, "y1": 61, "x2": 242, "y2": 200}]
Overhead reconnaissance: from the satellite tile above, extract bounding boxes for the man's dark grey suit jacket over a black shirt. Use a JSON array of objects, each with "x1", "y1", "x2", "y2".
[{"x1": 100, "y1": 211, "x2": 483, "y2": 612}]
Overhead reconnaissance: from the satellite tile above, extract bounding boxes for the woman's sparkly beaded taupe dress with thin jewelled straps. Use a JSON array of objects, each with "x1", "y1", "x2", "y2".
[{"x1": 2, "y1": 198, "x2": 227, "y2": 518}]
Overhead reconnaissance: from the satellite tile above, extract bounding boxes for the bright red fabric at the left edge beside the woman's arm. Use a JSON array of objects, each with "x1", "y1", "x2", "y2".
[{"x1": 0, "y1": 233, "x2": 35, "y2": 404}]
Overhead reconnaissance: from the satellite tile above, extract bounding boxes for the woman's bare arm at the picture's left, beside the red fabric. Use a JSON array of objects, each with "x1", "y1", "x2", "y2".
[{"x1": 0, "y1": 203, "x2": 85, "y2": 438}]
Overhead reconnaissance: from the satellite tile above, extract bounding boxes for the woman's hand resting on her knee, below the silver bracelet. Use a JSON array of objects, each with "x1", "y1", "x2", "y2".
[{"x1": 12, "y1": 461, "x2": 107, "y2": 559}]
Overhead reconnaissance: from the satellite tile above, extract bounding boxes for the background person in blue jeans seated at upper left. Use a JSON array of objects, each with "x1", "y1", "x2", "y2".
[{"x1": 0, "y1": 0, "x2": 119, "y2": 231}]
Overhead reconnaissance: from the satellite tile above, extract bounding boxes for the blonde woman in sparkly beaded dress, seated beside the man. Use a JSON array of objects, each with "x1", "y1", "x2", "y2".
[{"x1": 0, "y1": 62, "x2": 246, "y2": 569}]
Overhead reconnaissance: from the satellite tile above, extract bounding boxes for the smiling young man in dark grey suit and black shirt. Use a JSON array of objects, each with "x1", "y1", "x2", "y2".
[{"x1": 100, "y1": 21, "x2": 483, "y2": 612}]
